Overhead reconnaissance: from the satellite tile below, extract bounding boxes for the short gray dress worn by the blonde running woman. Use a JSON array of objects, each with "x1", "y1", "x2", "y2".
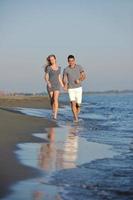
[{"x1": 45, "y1": 66, "x2": 61, "y2": 91}]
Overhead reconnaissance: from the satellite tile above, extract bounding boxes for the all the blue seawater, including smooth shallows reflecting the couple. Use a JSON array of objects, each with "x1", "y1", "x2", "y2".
[{"x1": 3, "y1": 94, "x2": 133, "y2": 200}]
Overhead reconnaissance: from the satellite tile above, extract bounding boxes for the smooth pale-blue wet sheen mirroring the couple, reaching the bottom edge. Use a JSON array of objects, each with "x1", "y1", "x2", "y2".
[{"x1": 3, "y1": 123, "x2": 115, "y2": 200}]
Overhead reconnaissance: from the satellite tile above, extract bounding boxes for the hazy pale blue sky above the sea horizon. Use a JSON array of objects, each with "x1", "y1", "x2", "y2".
[{"x1": 0, "y1": 0, "x2": 133, "y2": 92}]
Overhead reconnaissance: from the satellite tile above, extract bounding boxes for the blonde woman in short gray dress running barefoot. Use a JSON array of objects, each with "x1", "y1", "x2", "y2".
[{"x1": 45, "y1": 55, "x2": 64, "y2": 119}]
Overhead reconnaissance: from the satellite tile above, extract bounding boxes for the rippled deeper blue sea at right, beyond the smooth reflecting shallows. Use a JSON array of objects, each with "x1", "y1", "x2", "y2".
[{"x1": 55, "y1": 94, "x2": 133, "y2": 200}]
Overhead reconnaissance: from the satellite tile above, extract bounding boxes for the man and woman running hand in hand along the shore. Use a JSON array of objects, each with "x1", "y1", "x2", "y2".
[{"x1": 44, "y1": 55, "x2": 85, "y2": 122}]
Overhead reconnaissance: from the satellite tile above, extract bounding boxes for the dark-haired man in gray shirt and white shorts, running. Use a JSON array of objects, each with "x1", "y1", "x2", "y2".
[{"x1": 63, "y1": 55, "x2": 85, "y2": 122}]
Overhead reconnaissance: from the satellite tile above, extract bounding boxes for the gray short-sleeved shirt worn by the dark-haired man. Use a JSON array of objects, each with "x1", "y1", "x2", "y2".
[{"x1": 63, "y1": 65, "x2": 84, "y2": 88}]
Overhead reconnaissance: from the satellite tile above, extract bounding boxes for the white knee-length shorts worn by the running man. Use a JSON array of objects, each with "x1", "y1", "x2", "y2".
[{"x1": 68, "y1": 87, "x2": 82, "y2": 104}]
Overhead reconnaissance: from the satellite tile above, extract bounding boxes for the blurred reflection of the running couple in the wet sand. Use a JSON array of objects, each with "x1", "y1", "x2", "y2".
[{"x1": 39, "y1": 127, "x2": 78, "y2": 172}]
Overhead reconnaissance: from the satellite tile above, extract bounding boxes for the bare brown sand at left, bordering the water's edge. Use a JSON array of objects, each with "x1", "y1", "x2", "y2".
[{"x1": 0, "y1": 97, "x2": 56, "y2": 198}]
